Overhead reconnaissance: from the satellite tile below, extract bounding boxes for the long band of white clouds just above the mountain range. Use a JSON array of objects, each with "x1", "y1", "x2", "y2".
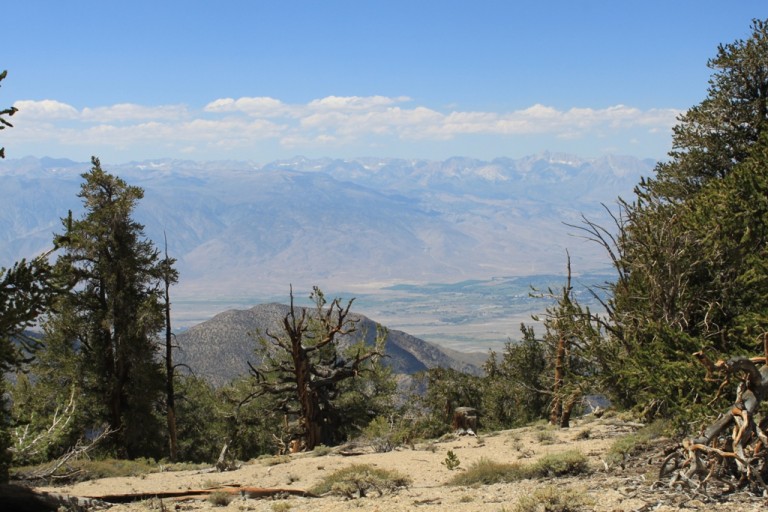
[{"x1": 3, "y1": 96, "x2": 680, "y2": 159}]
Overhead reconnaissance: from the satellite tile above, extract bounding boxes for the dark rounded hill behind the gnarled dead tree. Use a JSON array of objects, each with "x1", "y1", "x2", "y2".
[{"x1": 175, "y1": 303, "x2": 487, "y2": 385}]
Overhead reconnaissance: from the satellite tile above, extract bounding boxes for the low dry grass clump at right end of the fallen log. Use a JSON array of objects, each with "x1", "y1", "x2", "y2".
[{"x1": 310, "y1": 464, "x2": 411, "y2": 498}]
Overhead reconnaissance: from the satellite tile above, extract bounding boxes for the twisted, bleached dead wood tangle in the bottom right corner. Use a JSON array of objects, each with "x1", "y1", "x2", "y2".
[{"x1": 659, "y1": 350, "x2": 768, "y2": 494}]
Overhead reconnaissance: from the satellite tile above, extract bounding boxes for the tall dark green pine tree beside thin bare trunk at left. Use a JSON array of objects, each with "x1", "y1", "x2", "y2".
[{"x1": 39, "y1": 158, "x2": 168, "y2": 457}]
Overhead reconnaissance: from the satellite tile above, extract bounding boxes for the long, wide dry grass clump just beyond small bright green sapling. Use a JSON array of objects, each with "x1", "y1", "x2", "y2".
[{"x1": 448, "y1": 450, "x2": 589, "y2": 486}]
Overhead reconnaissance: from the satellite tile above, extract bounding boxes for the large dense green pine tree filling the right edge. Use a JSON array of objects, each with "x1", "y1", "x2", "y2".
[{"x1": 587, "y1": 20, "x2": 768, "y2": 416}]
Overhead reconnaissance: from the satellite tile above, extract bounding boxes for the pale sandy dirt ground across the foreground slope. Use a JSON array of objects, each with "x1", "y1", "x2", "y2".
[{"x1": 34, "y1": 419, "x2": 768, "y2": 512}]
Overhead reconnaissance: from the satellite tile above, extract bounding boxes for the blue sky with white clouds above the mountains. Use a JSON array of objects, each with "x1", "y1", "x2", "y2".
[{"x1": 0, "y1": 0, "x2": 768, "y2": 163}]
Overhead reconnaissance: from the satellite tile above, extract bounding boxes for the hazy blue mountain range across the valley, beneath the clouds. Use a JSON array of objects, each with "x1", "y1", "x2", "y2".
[{"x1": 0, "y1": 153, "x2": 654, "y2": 350}]
